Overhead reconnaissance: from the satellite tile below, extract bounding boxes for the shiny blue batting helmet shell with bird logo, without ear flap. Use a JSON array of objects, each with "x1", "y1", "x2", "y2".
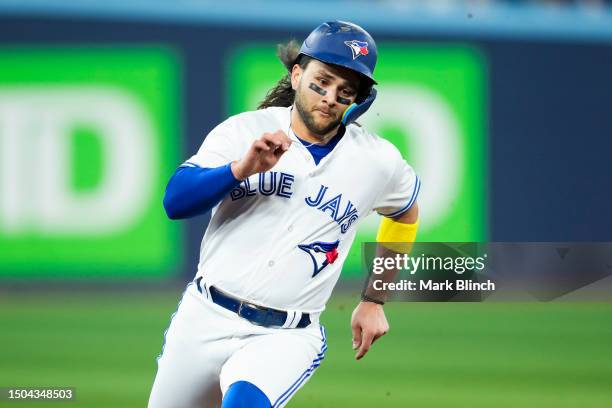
[{"x1": 299, "y1": 21, "x2": 378, "y2": 84}]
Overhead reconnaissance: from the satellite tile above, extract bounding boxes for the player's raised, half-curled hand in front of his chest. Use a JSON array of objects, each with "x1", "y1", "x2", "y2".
[{"x1": 231, "y1": 130, "x2": 291, "y2": 180}]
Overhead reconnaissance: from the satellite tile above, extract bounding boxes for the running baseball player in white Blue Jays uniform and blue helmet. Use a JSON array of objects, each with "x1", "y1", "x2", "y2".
[{"x1": 149, "y1": 21, "x2": 420, "y2": 408}]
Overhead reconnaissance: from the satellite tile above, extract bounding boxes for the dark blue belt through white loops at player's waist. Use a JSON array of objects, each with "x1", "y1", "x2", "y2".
[{"x1": 196, "y1": 277, "x2": 311, "y2": 329}]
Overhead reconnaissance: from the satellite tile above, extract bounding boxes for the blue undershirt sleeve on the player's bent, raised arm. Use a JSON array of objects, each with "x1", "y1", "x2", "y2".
[{"x1": 164, "y1": 163, "x2": 240, "y2": 220}]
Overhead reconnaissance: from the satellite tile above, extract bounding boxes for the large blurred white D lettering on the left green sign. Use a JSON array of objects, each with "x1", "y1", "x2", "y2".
[{"x1": 0, "y1": 86, "x2": 159, "y2": 236}]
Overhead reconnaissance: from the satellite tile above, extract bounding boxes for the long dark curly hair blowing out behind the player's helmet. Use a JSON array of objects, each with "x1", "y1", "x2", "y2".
[{"x1": 257, "y1": 40, "x2": 312, "y2": 109}]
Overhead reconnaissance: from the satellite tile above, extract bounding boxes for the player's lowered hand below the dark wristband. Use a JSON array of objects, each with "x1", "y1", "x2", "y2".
[{"x1": 351, "y1": 302, "x2": 389, "y2": 360}]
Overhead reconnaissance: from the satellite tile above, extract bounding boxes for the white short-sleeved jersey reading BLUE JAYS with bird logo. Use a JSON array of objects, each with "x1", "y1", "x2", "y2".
[{"x1": 183, "y1": 107, "x2": 420, "y2": 313}]
